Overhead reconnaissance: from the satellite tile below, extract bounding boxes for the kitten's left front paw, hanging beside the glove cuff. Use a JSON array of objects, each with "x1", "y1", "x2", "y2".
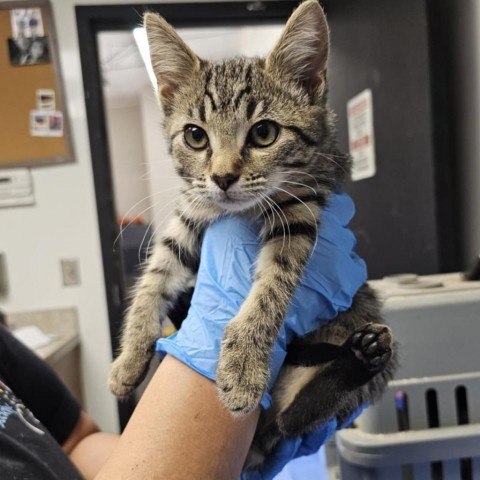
[{"x1": 108, "y1": 353, "x2": 151, "y2": 397}]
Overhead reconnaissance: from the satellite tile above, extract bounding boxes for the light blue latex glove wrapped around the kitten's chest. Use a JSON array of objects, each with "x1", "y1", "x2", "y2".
[{"x1": 157, "y1": 194, "x2": 367, "y2": 408}]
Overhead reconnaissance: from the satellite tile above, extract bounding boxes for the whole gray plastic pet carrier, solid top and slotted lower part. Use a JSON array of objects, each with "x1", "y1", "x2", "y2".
[{"x1": 336, "y1": 273, "x2": 480, "y2": 480}]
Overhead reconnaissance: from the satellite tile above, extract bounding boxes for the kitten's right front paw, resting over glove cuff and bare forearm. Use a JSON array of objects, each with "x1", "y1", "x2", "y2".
[{"x1": 216, "y1": 321, "x2": 270, "y2": 416}]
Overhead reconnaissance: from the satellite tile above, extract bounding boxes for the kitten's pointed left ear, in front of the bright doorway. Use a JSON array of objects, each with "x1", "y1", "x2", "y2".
[{"x1": 144, "y1": 13, "x2": 200, "y2": 102}]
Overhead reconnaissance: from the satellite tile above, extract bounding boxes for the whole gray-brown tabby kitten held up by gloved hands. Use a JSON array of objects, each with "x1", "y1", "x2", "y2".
[{"x1": 110, "y1": 0, "x2": 394, "y2": 463}]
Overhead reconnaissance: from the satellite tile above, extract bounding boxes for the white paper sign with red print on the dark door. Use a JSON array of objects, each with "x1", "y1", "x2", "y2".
[{"x1": 347, "y1": 89, "x2": 377, "y2": 182}]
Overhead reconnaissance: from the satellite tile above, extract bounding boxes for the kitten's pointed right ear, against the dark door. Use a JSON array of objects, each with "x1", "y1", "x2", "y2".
[{"x1": 266, "y1": 0, "x2": 330, "y2": 94}]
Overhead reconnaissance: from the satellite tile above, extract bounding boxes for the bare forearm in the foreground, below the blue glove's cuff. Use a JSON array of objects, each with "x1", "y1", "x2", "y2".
[{"x1": 96, "y1": 356, "x2": 259, "y2": 480}]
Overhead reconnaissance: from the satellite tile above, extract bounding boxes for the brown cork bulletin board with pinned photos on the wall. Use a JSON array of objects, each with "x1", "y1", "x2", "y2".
[{"x1": 0, "y1": 0, "x2": 73, "y2": 168}]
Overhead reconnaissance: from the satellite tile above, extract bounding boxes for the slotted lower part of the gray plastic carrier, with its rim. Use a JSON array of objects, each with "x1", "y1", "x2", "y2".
[{"x1": 336, "y1": 373, "x2": 480, "y2": 480}]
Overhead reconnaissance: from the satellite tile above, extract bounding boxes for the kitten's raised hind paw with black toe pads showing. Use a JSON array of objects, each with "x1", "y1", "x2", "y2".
[{"x1": 347, "y1": 323, "x2": 393, "y2": 372}]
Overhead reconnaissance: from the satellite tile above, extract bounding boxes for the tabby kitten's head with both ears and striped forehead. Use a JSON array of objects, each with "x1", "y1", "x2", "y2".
[{"x1": 145, "y1": 0, "x2": 347, "y2": 211}]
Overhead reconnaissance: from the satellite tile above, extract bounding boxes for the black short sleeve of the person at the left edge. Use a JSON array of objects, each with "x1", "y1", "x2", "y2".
[{"x1": 0, "y1": 325, "x2": 81, "y2": 445}]
